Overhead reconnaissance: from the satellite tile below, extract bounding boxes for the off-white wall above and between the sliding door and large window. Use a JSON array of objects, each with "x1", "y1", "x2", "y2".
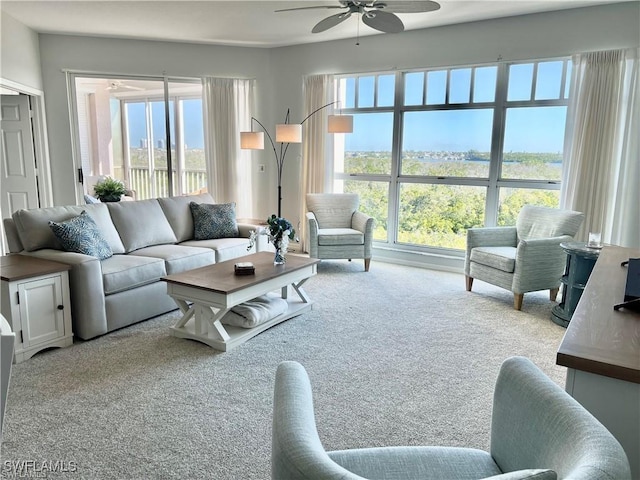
[{"x1": 30, "y1": 2, "x2": 640, "y2": 225}]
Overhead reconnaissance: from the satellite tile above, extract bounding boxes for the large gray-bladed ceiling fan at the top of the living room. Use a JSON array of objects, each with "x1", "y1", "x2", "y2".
[{"x1": 276, "y1": 0, "x2": 440, "y2": 33}]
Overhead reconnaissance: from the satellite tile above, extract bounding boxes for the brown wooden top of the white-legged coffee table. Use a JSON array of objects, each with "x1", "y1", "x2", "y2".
[{"x1": 162, "y1": 252, "x2": 320, "y2": 294}]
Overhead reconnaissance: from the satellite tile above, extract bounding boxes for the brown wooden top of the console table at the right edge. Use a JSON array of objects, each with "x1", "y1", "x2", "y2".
[{"x1": 556, "y1": 246, "x2": 640, "y2": 383}]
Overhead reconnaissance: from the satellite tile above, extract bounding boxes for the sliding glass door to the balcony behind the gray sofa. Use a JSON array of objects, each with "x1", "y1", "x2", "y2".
[{"x1": 74, "y1": 76, "x2": 207, "y2": 200}]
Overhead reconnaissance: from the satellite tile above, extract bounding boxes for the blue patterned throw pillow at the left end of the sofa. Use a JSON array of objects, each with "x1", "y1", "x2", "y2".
[{"x1": 49, "y1": 211, "x2": 113, "y2": 260}]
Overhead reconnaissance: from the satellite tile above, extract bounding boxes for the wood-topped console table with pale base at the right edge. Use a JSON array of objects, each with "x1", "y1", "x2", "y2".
[{"x1": 556, "y1": 246, "x2": 640, "y2": 478}]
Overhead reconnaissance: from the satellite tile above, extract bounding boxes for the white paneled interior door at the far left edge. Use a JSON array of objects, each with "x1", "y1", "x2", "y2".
[{"x1": 0, "y1": 95, "x2": 39, "y2": 218}]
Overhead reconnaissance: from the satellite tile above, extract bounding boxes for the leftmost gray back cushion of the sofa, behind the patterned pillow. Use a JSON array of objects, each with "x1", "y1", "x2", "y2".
[{"x1": 13, "y1": 203, "x2": 124, "y2": 253}]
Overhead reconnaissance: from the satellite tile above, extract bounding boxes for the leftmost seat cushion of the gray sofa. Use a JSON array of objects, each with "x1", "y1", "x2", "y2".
[{"x1": 102, "y1": 255, "x2": 167, "y2": 295}]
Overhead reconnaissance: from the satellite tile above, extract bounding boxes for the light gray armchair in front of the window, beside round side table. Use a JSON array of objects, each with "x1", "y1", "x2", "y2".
[{"x1": 464, "y1": 205, "x2": 584, "y2": 310}]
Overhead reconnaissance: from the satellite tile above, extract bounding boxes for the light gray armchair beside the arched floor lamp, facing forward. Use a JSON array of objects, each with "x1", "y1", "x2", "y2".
[{"x1": 306, "y1": 193, "x2": 373, "y2": 272}]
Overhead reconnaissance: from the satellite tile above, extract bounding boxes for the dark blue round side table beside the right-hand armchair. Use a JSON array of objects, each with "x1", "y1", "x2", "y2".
[{"x1": 551, "y1": 242, "x2": 601, "y2": 328}]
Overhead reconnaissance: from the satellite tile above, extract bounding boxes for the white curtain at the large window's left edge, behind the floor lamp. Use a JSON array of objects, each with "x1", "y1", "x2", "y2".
[{"x1": 299, "y1": 75, "x2": 335, "y2": 251}]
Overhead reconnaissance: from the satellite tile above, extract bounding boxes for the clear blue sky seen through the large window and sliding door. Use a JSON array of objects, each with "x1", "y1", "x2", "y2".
[{"x1": 128, "y1": 61, "x2": 569, "y2": 153}]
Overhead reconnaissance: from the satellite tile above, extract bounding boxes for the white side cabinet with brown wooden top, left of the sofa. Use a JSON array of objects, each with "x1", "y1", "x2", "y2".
[{"x1": 0, "y1": 255, "x2": 73, "y2": 363}]
